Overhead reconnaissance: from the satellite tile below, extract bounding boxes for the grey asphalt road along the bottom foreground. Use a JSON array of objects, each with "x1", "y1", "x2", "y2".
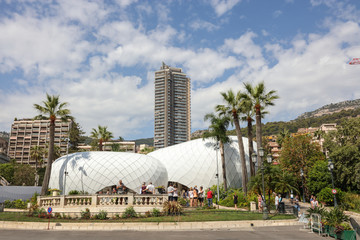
[{"x1": 0, "y1": 226, "x2": 324, "y2": 240}]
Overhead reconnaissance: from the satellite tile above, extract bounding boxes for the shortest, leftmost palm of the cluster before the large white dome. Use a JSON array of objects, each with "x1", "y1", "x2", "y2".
[{"x1": 203, "y1": 113, "x2": 230, "y2": 191}]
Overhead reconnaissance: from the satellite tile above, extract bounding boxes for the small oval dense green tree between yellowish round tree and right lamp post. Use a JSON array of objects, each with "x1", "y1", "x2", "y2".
[{"x1": 306, "y1": 160, "x2": 331, "y2": 195}]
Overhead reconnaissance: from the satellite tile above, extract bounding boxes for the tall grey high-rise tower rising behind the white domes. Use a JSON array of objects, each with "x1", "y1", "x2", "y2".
[{"x1": 154, "y1": 63, "x2": 191, "y2": 149}]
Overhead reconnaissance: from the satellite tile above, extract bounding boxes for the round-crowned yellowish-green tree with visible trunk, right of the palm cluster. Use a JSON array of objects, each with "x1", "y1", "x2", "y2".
[{"x1": 279, "y1": 135, "x2": 325, "y2": 199}]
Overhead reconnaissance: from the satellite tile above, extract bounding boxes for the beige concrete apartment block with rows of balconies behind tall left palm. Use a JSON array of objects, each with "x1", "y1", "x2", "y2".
[{"x1": 8, "y1": 119, "x2": 70, "y2": 165}]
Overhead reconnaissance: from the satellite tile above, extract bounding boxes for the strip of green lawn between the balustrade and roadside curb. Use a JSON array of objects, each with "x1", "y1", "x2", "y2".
[{"x1": 0, "y1": 210, "x2": 295, "y2": 222}]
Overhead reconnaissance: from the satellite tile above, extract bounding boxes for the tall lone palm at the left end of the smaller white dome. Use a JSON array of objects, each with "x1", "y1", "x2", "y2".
[{"x1": 34, "y1": 94, "x2": 72, "y2": 196}]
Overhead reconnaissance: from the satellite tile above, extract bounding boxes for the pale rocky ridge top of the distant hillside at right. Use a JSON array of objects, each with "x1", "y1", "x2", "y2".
[{"x1": 295, "y1": 99, "x2": 360, "y2": 120}]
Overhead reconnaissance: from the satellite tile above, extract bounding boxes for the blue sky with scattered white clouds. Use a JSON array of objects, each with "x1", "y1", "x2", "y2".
[{"x1": 0, "y1": 0, "x2": 360, "y2": 139}]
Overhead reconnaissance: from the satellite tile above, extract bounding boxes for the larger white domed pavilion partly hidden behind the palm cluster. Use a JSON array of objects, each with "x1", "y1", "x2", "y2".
[{"x1": 148, "y1": 136, "x2": 256, "y2": 188}]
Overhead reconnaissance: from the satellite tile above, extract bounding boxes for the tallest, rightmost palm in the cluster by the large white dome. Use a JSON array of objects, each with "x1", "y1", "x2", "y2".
[{"x1": 244, "y1": 82, "x2": 279, "y2": 167}]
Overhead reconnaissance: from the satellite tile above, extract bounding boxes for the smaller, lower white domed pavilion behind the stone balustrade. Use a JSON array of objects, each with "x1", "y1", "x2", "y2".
[{"x1": 49, "y1": 152, "x2": 168, "y2": 194}]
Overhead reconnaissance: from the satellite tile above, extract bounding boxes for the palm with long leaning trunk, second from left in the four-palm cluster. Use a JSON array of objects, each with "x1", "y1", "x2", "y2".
[{"x1": 216, "y1": 89, "x2": 248, "y2": 195}]
